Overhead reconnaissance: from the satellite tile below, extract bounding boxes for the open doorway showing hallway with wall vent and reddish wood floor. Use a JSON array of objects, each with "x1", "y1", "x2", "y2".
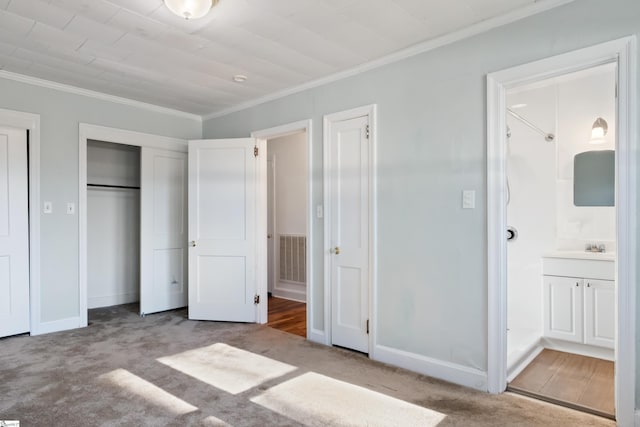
[{"x1": 266, "y1": 131, "x2": 308, "y2": 338}]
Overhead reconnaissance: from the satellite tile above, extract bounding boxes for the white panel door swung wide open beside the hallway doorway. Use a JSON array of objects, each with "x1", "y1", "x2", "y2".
[{"x1": 189, "y1": 138, "x2": 258, "y2": 322}]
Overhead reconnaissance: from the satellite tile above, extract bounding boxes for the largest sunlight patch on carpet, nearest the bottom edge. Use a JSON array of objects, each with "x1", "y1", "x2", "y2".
[{"x1": 251, "y1": 372, "x2": 446, "y2": 427}]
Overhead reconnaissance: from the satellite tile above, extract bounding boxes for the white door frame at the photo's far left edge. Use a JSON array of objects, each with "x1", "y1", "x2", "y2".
[{"x1": 0, "y1": 108, "x2": 41, "y2": 335}]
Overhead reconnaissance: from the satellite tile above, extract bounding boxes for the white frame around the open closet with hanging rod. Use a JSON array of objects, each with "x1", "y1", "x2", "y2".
[{"x1": 77, "y1": 123, "x2": 187, "y2": 328}]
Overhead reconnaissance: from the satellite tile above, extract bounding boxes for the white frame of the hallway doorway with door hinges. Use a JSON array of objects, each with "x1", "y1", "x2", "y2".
[{"x1": 251, "y1": 119, "x2": 312, "y2": 334}]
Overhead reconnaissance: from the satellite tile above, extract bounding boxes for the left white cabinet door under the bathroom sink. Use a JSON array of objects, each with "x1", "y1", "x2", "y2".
[{"x1": 543, "y1": 276, "x2": 583, "y2": 343}]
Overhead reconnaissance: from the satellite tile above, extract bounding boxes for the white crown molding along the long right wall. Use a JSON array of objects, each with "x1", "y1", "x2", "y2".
[{"x1": 202, "y1": 0, "x2": 575, "y2": 120}]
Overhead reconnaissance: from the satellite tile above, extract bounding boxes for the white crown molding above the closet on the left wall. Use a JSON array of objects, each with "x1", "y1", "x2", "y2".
[{"x1": 0, "y1": 70, "x2": 202, "y2": 122}]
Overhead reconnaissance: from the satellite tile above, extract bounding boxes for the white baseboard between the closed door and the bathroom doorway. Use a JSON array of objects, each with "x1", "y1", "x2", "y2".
[{"x1": 374, "y1": 344, "x2": 488, "y2": 391}]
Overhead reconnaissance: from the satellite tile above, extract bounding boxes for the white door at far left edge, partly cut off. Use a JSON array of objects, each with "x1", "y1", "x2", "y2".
[{"x1": 0, "y1": 128, "x2": 29, "y2": 337}]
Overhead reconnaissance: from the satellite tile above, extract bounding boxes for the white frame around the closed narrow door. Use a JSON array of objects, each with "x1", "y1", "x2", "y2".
[{"x1": 322, "y1": 104, "x2": 378, "y2": 359}]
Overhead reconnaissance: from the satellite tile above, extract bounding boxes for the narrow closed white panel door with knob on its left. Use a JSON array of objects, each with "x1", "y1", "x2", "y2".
[{"x1": 328, "y1": 116, "x2": 369, "y2": 353}]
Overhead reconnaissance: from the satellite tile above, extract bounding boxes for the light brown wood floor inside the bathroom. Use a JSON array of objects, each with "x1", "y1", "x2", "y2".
[{"x1": 508, "y1": 349, "x2": 615, "y2": 418}]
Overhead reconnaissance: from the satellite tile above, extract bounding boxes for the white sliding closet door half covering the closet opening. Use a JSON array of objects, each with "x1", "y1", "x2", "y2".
[{"x1": 140, "y1": 147, "x2": 188, "y2": 314}]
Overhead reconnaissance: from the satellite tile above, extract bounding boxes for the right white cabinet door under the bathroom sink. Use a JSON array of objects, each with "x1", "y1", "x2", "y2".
[{"x1": 584, "y1": 279, "x2": 616, "y2": 348}]
